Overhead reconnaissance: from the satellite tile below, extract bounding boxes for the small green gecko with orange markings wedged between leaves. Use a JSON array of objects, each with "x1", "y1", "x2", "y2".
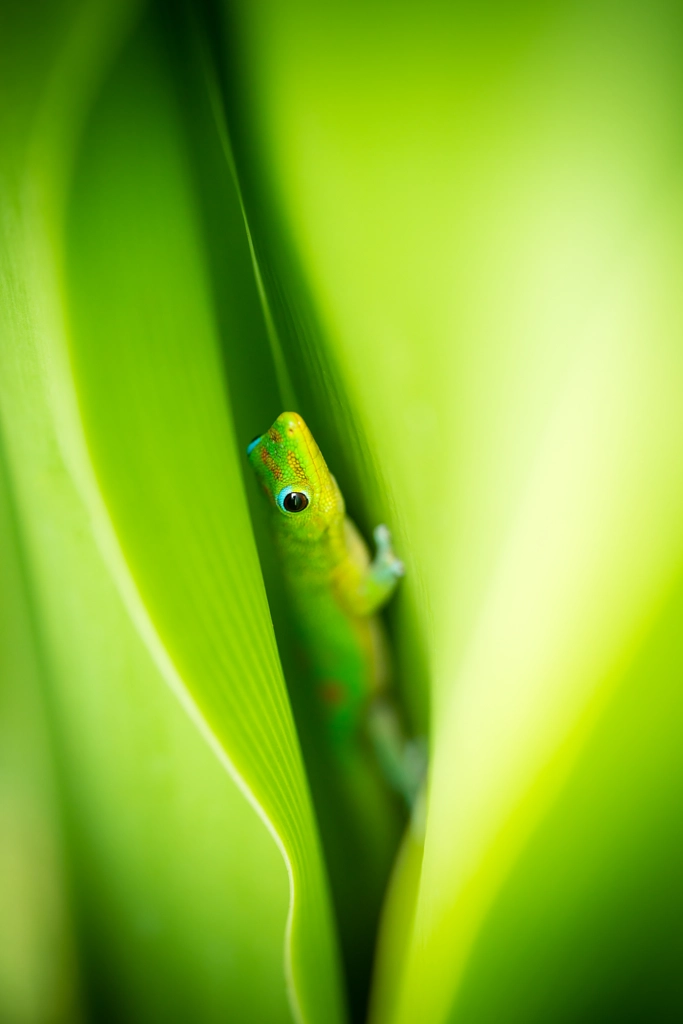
[{"x1": 247, "y1": 413, "x2": 424, "y2": 807}]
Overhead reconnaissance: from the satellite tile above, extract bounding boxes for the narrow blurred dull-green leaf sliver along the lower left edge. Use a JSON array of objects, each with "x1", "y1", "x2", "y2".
[{"x1": 0, "y1": 432, "x2": 80, "y2": 1024}]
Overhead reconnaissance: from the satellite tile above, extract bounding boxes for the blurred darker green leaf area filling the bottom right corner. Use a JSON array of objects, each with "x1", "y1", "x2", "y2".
[{"x1": 449, "y1": 583, "x2": 683, "y2": 1024}]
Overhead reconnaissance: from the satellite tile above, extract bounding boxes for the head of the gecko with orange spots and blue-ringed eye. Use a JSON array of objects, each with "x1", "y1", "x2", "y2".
[{"x1": 247, "y1": 413, "x2": 344, "y2": 537}]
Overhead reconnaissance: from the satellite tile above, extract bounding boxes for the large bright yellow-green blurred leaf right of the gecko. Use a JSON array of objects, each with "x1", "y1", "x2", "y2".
[{"x1": 226, "y1": 0, "x2": 683, "y2": 1024}]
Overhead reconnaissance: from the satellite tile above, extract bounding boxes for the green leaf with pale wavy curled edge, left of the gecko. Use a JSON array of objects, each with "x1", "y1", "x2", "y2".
[{"x1": 0, "y1": 4, "x2": 342, "y2": 1022}]
